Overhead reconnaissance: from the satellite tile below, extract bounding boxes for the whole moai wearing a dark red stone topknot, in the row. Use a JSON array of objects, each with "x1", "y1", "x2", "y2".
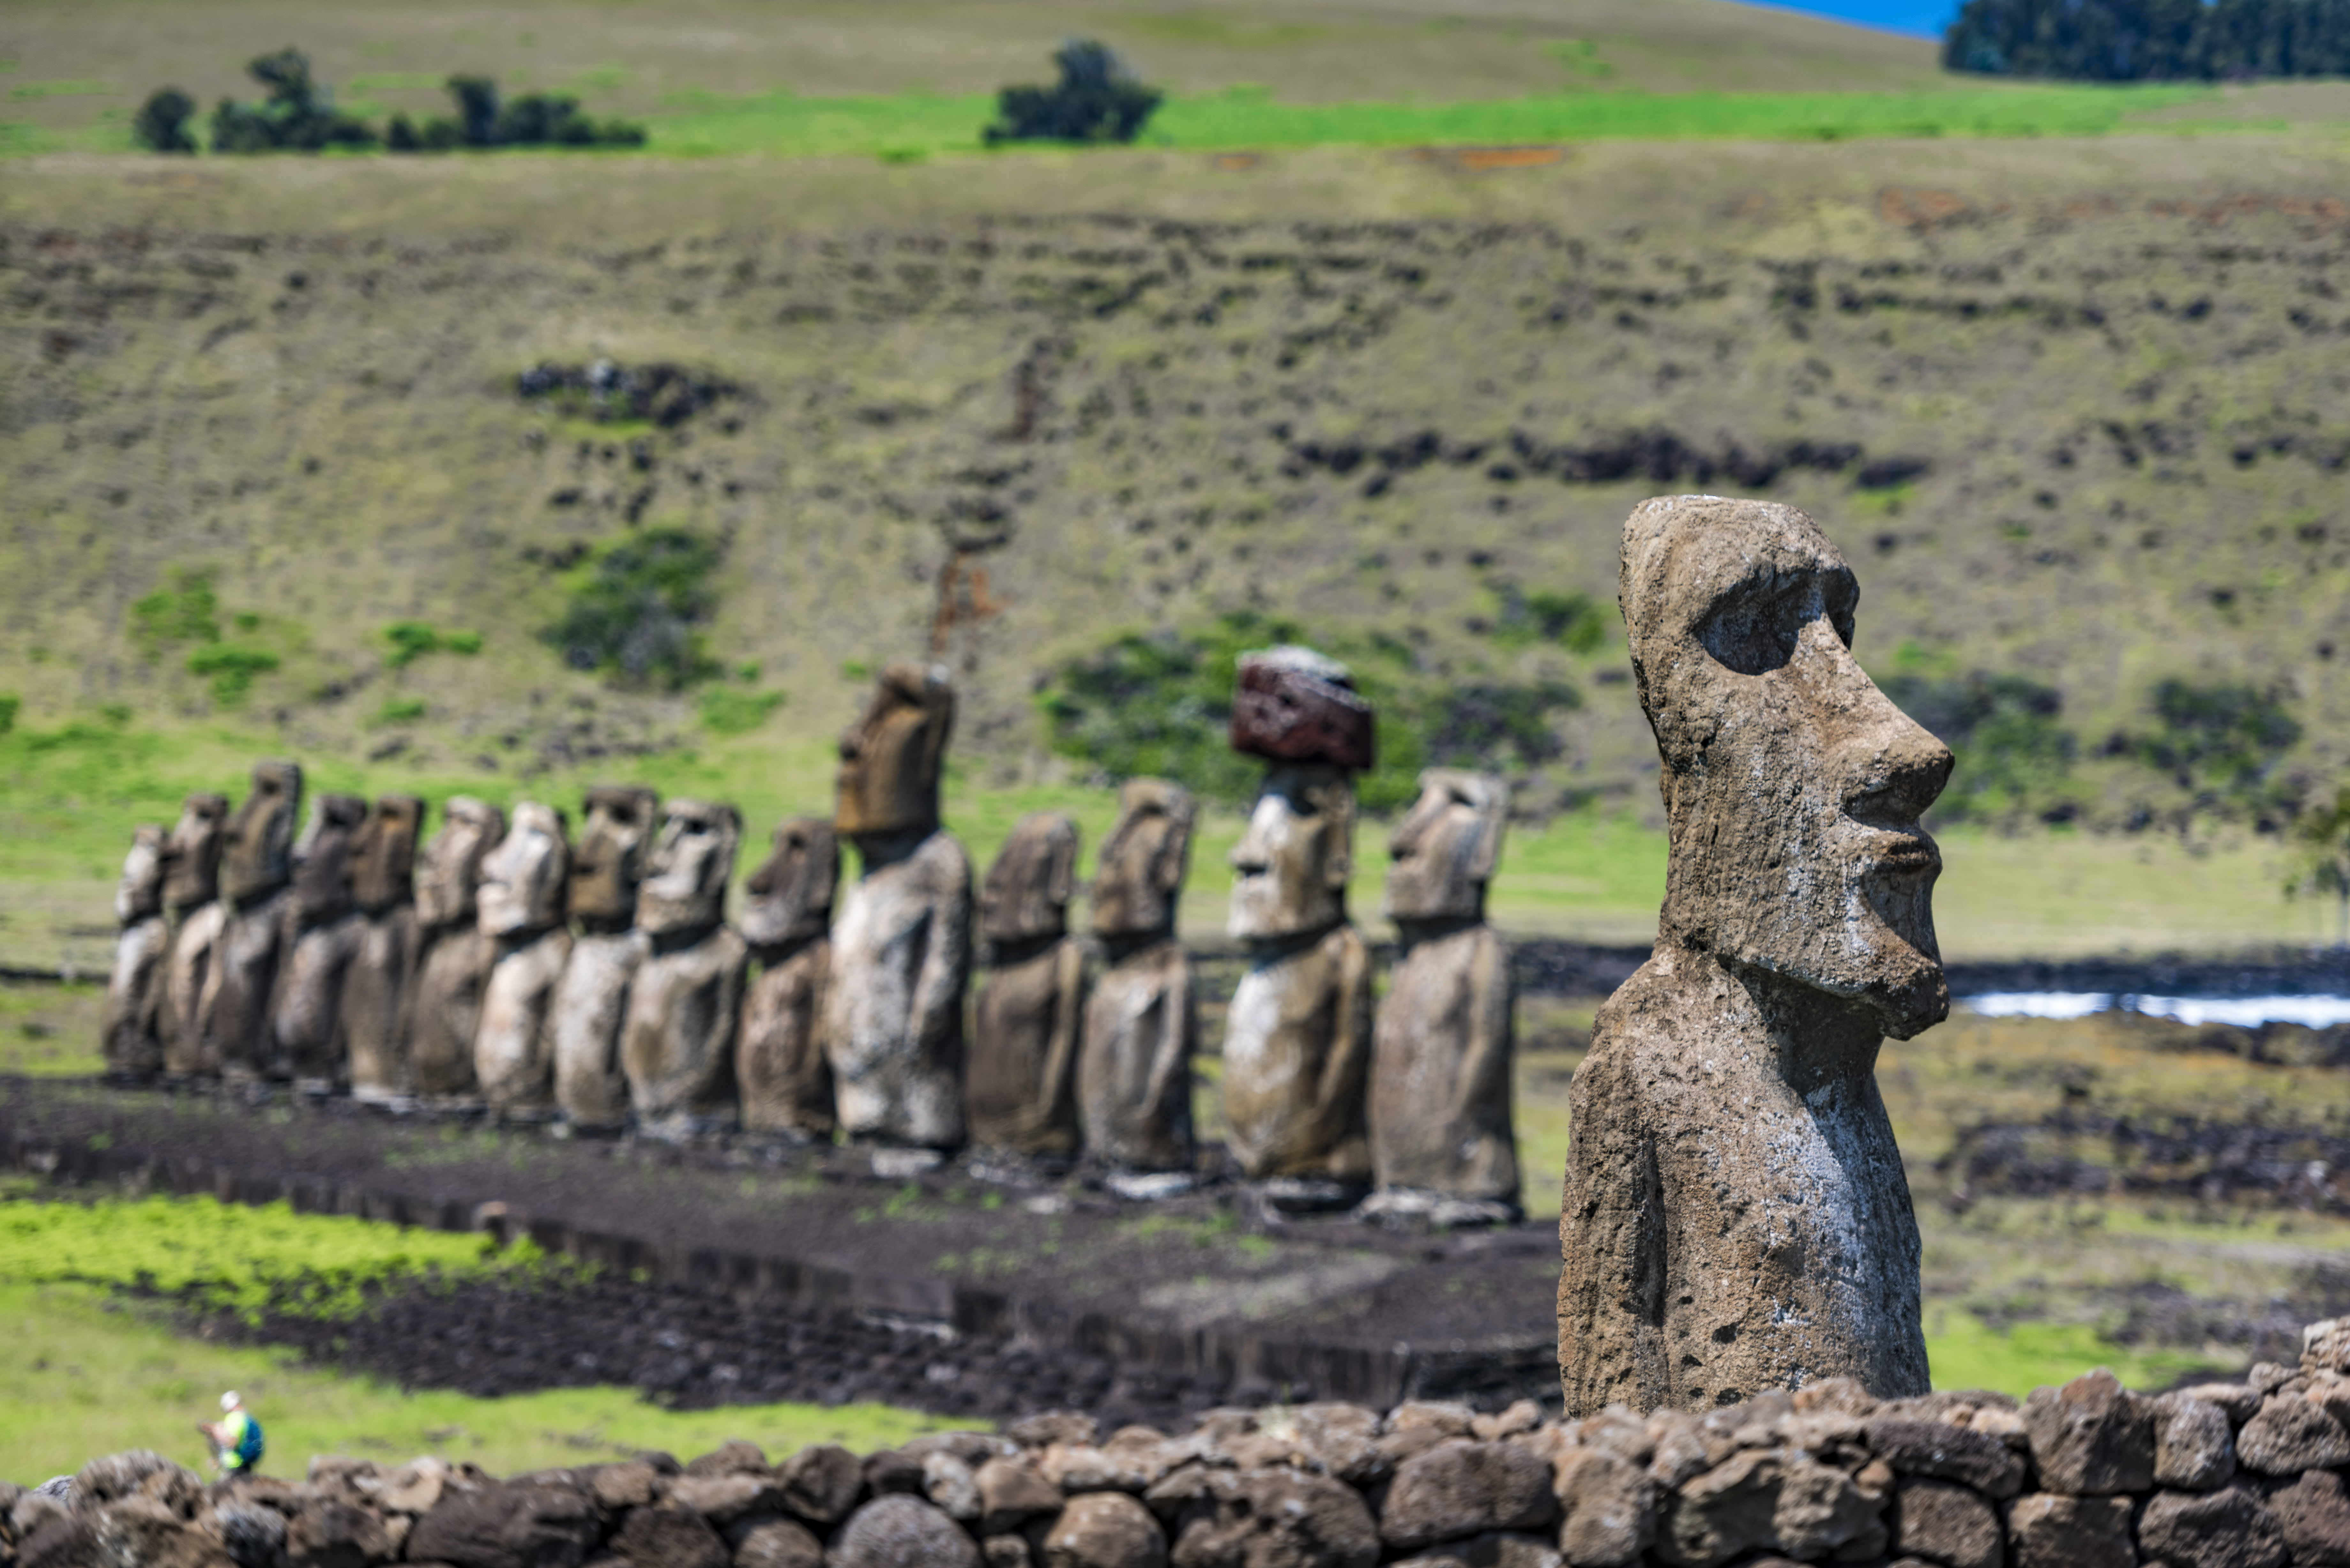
[{"x1": 1224, "y1": 649, "x2": 1372, "y2": 1206}]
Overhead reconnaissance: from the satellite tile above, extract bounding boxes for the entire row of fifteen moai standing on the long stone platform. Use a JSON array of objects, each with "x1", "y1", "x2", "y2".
[{"x1": 103, "y1": 649, "x2": 1518, "y2": 1218}]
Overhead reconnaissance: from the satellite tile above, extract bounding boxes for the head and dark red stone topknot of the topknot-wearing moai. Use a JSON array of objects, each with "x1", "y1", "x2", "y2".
[{"x1": 1227, "y1": 646, "x2": 1375, "y2": 940}]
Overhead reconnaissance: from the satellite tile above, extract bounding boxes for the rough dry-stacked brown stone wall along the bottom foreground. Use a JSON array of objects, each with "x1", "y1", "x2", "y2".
[{"x1": 23, "y1": 1319, "x2": 2350, "y2": 1568}]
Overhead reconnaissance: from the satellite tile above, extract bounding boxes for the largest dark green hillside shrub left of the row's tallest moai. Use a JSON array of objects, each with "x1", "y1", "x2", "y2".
[{"x1": 541, "y1": 529, "x2": 719, "y2": 691}]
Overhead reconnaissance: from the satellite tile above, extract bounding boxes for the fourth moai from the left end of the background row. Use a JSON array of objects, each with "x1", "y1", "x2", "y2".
[{"x1": 270, "y1": 795, "x2": 367, "y2": 1093}]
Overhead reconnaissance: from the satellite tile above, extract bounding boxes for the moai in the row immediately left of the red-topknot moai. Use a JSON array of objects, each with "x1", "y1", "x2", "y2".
[{"x1": 1076, "y1": 778, "x2": 1199, "y2": 1171}]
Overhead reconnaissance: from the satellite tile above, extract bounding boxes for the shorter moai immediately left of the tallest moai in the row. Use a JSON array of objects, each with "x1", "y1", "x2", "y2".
[{"x1": 736, "y1": 816, "x2": 841, "y2": 1142}]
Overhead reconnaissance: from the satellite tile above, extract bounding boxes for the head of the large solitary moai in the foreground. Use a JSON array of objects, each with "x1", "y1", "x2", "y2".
[{"x1": 1621, "y1": 496, "x2": 1951, "y2": 1039}]
